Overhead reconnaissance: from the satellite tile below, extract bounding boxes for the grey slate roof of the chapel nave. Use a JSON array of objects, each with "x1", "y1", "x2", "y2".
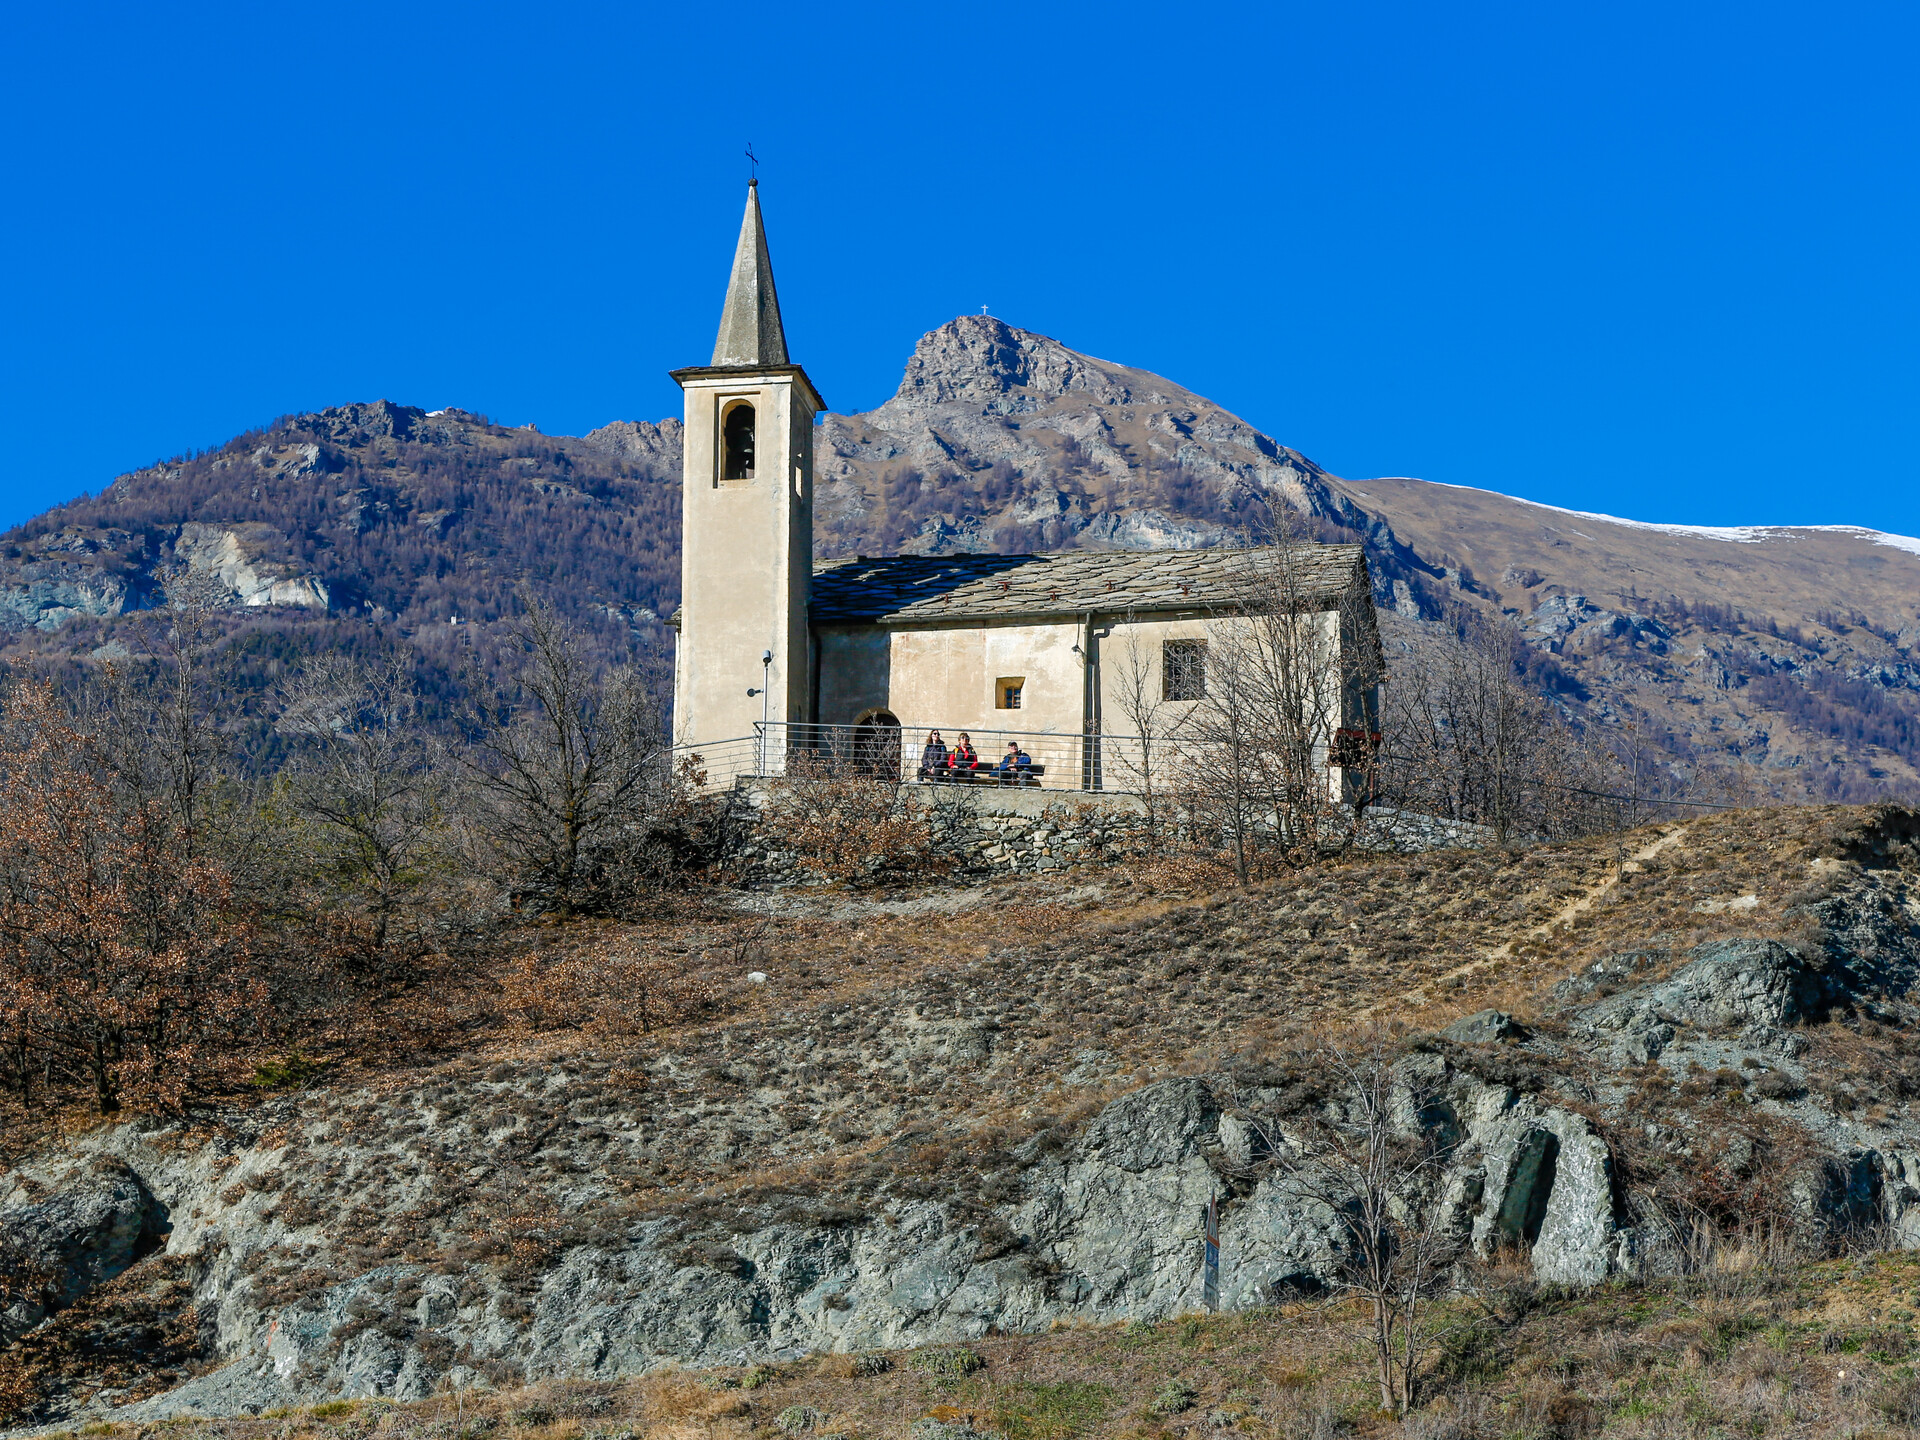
[{"x1": 808, "y1": 545, "x2": 1367, "y2": 626}]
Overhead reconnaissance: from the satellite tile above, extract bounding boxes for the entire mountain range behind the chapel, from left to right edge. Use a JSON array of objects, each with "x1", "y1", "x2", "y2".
[{"x1": 0, "y1": 315, "x2": 1920, "y2": 799}]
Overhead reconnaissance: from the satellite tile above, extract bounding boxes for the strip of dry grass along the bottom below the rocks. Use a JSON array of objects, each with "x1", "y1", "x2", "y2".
[{"x1": 26, "y1": 1256, "x2": 1920, "y2": 1440}]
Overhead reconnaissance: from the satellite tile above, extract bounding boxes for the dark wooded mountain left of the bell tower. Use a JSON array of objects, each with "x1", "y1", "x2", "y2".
[{"x1": 0, "y1": 399, "x2": 680, "y2": 632}]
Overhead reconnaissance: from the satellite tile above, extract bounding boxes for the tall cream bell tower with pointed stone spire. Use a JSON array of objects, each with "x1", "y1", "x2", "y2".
[{"x1": 672, "y1": 180, "x2": 826, "y2": 745}]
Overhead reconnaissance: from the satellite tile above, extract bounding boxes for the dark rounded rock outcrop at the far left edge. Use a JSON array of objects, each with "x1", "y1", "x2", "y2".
[{"x1": 0, "y1": 1160, "x2": 163, "y2": 1342}]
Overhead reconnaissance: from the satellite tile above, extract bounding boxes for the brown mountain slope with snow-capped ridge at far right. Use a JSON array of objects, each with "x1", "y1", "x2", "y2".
[{"x1": 1331, "y1": 478, "x2": 1920, "y2": 797}]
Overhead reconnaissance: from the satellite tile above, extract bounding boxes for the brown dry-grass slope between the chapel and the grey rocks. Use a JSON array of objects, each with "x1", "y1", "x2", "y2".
[{"x1": 22, "y1": 808, "x2": 1908, "y2": 1246}]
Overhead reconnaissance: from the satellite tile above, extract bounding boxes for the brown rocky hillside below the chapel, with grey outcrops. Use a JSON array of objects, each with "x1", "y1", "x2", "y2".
[{"x1": 0, "y1": 808, "x2": 1920, "y2": 1440}]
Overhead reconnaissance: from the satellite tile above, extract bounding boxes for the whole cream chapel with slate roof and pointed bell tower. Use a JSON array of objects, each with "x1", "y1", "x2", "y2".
[{"x1": 672, "y1": 180, "x2": 1380, "y2": 795}]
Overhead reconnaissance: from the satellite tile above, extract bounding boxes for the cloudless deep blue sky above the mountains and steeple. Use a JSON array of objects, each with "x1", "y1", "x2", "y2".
[{"x1": 0, "y1": 0, "x2": 1920, "y2": 534}]
